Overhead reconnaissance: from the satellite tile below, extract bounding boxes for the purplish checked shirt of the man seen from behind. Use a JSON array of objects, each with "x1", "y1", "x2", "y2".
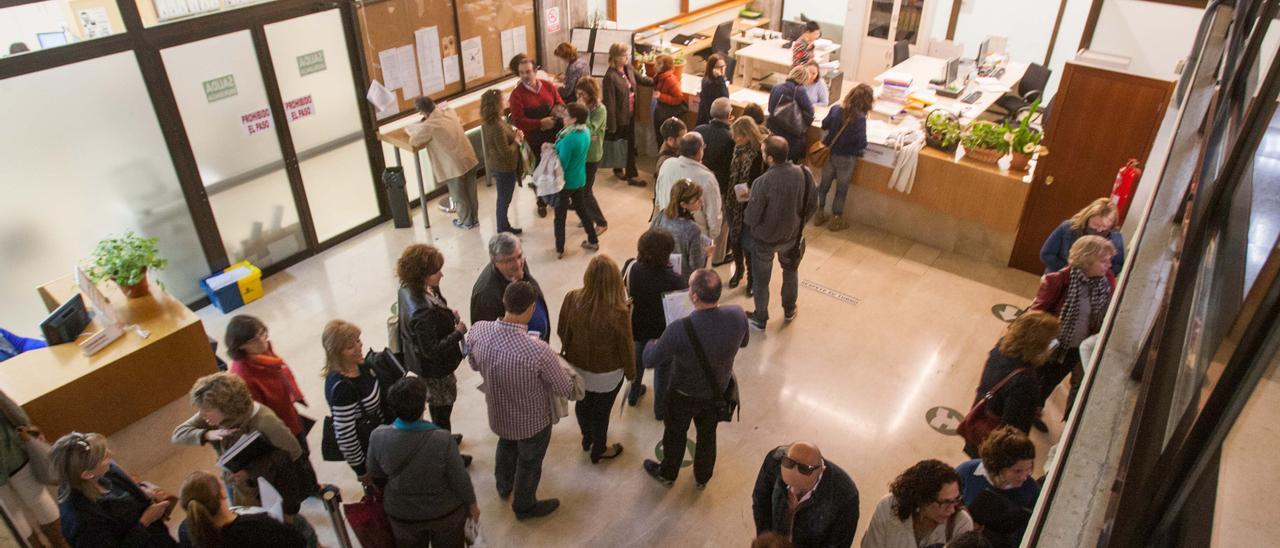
[{"x1": 467, "y1": 320, "x2": 573, "y2": 439}]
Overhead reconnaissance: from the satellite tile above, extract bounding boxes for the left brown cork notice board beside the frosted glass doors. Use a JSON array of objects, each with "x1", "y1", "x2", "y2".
[{"x1": 356, "y1": 0, "x2": 462, "y2": 113}]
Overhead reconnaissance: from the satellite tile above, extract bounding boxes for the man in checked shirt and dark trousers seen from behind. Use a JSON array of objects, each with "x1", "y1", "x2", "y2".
[{"x1": 467, "y1": 282, "x2": 573, "y2": 520}]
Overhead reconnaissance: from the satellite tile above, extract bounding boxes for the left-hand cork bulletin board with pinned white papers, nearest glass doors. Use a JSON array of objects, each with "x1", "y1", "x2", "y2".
[{"x1": 356, "y1": 0, "x2": 465, "y2": 113}]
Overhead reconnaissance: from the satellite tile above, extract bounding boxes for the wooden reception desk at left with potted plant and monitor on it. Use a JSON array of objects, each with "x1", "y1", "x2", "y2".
[{"x1": 0, "y1": 277, "x2": 218, "y2": 440}]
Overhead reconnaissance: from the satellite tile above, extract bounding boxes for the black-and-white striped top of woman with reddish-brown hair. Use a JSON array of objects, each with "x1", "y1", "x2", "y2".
[{"x1": 325, "y1": 365, "x2": 383, "y2": 475}]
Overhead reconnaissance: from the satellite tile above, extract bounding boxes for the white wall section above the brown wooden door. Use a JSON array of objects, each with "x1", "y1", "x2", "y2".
[{"x1": 1091, "y1": 0, "x2": 1203, "y2": 79}]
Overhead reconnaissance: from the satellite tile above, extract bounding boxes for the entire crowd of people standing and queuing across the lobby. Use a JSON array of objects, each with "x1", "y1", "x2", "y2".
[{"x1": 0, "y1": 39, "x2": 1123, "y2": 548}]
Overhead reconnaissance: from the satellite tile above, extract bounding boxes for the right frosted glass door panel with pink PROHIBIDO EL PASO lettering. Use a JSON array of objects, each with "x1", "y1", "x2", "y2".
[{"x1": 266, "y1": 9, "x2": 379, "y2": 242}]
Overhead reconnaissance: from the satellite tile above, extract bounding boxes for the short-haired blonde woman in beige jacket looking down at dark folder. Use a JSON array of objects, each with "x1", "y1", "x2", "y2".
[{"x1": 170, "y1": 373, "x2": 316, "y2": 544}]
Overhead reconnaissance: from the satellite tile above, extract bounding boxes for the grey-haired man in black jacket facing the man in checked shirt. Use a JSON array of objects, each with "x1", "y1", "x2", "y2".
[{"x1": 471, "y1": 232, "x2": 552, "y2": 343}]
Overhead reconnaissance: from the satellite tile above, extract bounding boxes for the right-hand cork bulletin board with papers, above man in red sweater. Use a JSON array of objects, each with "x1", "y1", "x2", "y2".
[{"x1": 458, "y1": 0, "x2": 538, "y2": 88}]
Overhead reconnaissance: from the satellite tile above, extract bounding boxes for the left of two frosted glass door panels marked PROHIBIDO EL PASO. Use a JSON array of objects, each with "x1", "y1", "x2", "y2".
[{"x1": 160, "y1": 31, "x2": 306, "y2": 266}]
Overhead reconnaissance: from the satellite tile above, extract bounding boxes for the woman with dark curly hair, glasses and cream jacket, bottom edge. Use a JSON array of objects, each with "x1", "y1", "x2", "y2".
[{"x1": 863, "y1": 458, "x2": 973, "y2": 548}]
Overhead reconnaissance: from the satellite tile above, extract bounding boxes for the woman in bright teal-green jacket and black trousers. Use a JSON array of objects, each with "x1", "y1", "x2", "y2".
[{"x1": 548, "y1": 102, "x2": 600, "y2": 259}]
